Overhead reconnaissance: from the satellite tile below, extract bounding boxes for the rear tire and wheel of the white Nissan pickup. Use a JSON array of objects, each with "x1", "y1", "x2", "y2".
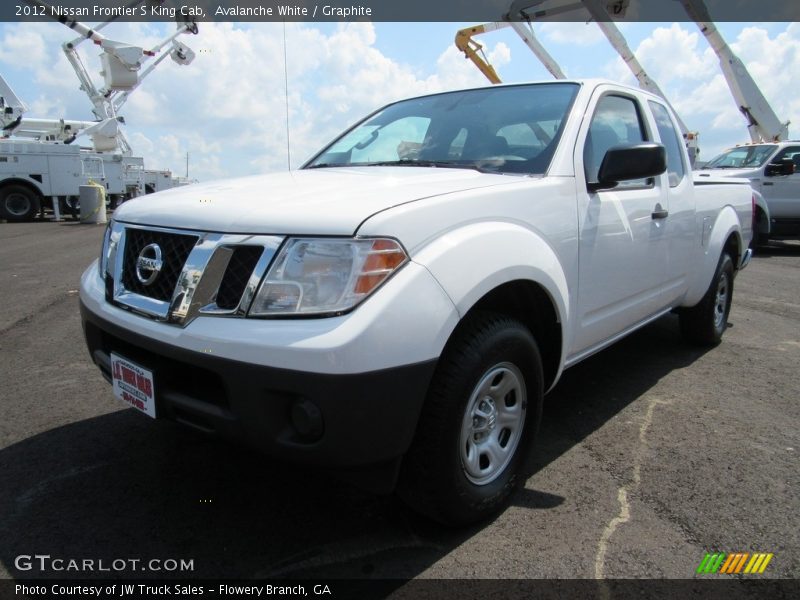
[{"x1": 679, "y1": 252, "x2": 734, "y2": 346}]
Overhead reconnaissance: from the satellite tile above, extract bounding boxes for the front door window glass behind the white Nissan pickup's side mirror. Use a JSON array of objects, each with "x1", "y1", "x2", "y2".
[{"x1": 583, "y1": 96, "x2": 653, "y2": 189}]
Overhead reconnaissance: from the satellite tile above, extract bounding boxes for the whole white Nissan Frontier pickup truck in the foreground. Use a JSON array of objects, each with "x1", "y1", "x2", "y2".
[{"x1": 80, "y1": 80, "x2": 753, "y2": 524}]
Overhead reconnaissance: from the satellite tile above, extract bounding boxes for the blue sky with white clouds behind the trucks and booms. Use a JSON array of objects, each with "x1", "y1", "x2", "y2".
[{"x1": 0, "y1": 23, "x2": 800, "y2": 180}]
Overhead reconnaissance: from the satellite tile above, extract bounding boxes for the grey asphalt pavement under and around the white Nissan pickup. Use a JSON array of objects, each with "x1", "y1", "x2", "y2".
[{"x1": 0, "y1": 221, "x2": 800, "y2": 592}]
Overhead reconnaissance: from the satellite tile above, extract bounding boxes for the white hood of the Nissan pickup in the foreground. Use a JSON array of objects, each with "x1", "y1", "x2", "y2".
[{"x1": 114, "y1": 167, "x2": 519, "y2": 235}]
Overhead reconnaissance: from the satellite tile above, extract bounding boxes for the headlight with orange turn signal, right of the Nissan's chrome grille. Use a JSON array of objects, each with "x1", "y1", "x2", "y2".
[{"x1": 250, "y1": 238, "x2": 408, "y2": 317}]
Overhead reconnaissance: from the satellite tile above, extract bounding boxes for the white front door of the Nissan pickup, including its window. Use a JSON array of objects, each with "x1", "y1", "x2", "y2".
[{"x1": 572, "y1": 93, "x2": 668, "y2": 355}]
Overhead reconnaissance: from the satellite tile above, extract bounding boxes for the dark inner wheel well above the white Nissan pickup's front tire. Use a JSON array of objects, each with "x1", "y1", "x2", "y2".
[{"x1": 462, "y1": 279, "x2": 563, "y2": 391}]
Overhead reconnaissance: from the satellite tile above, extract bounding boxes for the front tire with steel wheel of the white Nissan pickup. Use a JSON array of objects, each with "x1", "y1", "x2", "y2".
[{"x1": 397, "y1": 312, "x2": 543, "y2": 525}]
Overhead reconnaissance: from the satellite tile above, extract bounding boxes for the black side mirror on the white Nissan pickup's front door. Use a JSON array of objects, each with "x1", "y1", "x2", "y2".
[{"x1": 589, "y1": 142, "x2": 667, "y2": 192}]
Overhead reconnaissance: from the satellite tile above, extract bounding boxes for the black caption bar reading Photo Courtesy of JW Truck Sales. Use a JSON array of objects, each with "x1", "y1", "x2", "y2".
[{"x1": 0, "y1": 575, "x2": 800, "y2": 600}]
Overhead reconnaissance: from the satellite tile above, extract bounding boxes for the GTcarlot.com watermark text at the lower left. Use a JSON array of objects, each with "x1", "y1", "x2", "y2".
[{"x1": 14, "y1": 554, "x2": 194, "y2": 573}]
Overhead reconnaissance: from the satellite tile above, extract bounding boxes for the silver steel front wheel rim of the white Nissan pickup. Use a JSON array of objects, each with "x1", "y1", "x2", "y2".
[{"x1": 459, "y1": 362, "x2": 527, "y2": 485}]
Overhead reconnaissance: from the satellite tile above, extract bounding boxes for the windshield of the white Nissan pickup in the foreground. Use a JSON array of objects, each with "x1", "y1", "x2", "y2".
[{"x1": 303, "y1": 83, "x2": 578, "y2": 175}]
